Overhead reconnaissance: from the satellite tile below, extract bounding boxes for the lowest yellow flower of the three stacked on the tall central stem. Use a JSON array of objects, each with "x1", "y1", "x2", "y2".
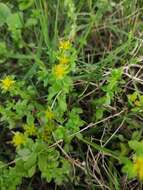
[{"x1": 54, "y1": 64, "x2": 67, "y2": 79}]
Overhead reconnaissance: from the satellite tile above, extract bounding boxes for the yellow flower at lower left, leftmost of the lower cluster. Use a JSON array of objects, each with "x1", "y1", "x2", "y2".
[{"x1": 12, "y1": 132, "x2": 26, "y2": 147}]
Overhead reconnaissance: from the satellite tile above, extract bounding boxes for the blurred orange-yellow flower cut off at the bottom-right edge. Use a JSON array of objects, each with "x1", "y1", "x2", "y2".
[{"x1": 134, "y1": 157, "x2": 143, "y2": 180}]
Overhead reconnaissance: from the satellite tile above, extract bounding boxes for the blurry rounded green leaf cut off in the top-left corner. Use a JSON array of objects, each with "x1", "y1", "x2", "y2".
[{"x1": 0, "y1": 3, "x2": 11, "y2": 26}]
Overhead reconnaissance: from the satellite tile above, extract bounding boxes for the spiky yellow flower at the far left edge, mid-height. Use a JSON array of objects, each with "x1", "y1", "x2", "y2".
[{"x1": 1, "y1": 76, "x2": 15, "y2": 91}]
